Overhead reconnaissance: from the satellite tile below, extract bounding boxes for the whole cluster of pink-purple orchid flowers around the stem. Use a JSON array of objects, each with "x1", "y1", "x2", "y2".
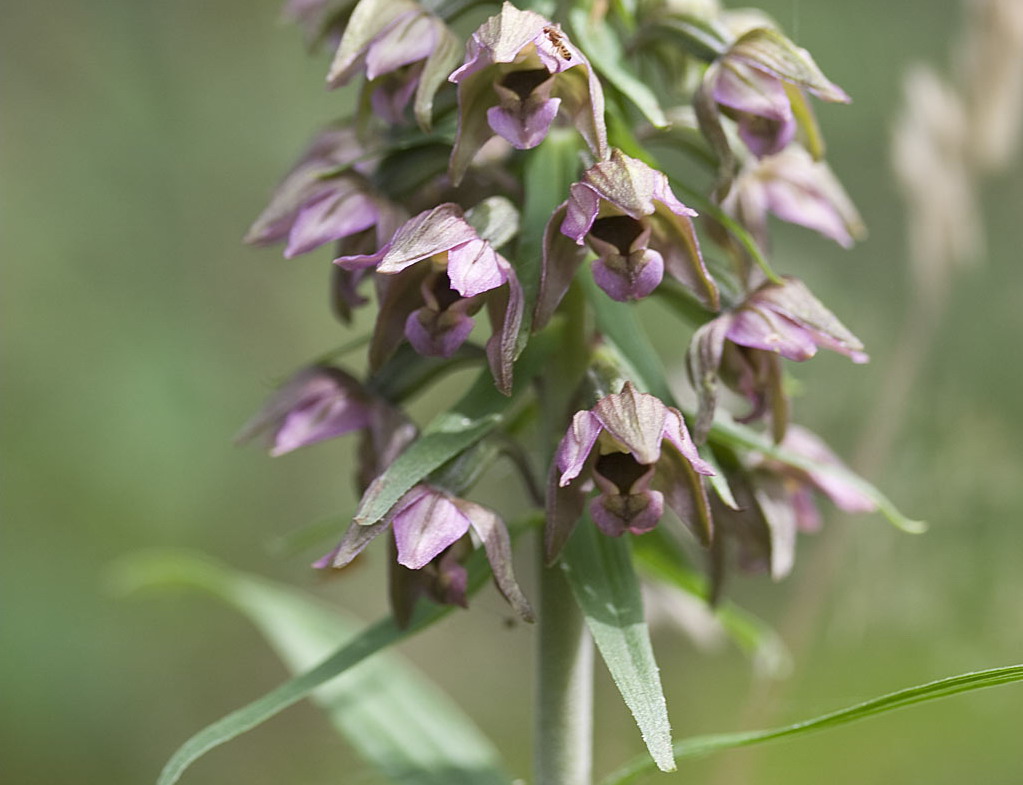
[{"x1": 243, "y1": 0, "x2": 874, "y2": 619}]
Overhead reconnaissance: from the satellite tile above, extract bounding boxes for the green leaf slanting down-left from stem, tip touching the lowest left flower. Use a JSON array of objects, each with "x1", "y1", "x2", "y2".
[{"x1": 355, "y1": 334, "x2": 554, "y2": 526}]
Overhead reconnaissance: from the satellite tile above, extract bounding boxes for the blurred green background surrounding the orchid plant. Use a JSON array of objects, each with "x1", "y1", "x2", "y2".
[{"x1": 0, "y1": 0, "x2": 1023, "y2": 785}]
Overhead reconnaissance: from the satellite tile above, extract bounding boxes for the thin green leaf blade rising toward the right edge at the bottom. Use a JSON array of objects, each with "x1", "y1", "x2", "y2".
[{"x1": 601, "y1": 665, "x2": 1023, "y2": 785}]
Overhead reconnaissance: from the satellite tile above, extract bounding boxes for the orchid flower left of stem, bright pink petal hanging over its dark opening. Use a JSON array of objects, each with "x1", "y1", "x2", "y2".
[{"x1": 335, "y1": 203, "x2": 523, "y2": 392}]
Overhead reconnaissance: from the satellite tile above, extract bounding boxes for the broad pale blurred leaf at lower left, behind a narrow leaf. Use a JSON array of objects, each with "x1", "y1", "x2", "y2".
[{"x1": 116, "y1": 554, "x2": 510, "y2": 785}]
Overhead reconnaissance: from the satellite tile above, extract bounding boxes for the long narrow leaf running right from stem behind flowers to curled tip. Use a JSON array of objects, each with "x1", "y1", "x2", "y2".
[{"x1": 583, "y1": 276, "x2": 927, "y2": 534}]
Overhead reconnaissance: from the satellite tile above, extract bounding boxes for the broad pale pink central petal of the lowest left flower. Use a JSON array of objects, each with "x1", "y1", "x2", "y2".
[{"x1": 389, "y1": 485, "x2": 470, "y2": 570}]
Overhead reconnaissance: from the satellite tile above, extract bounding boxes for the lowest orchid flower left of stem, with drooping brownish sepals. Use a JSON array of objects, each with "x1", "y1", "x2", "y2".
[{"x1": 314, "y1": 484, "x2": 533, "y2": 621}]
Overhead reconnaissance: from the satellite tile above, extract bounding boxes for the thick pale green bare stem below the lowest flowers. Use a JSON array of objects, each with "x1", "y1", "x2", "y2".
[{"x1": 534, "y1": 537, "x2": 593, "y2": 785}]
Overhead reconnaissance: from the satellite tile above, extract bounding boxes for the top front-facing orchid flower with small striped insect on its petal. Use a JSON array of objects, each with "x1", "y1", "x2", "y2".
[{"x1": 450, "y1": 2, "x2": 608, "y2": 184}]
